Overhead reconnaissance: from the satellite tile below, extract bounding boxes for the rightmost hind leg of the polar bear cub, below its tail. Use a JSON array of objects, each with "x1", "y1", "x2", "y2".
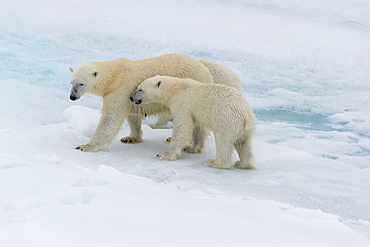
[{"x1": 234, "y1": 135, "x2": 256, "y2": 169}]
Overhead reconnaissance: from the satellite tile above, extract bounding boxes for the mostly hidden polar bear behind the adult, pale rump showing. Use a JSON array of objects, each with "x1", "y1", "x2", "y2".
[{"x1": 148, "y1": 59, "x2": 243, "y2": 129}]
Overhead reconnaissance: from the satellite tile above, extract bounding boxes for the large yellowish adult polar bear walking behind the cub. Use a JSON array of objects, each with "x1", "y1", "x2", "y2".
[{"x1": 70, "y1": 54, "x2": 241, "y2": 152}]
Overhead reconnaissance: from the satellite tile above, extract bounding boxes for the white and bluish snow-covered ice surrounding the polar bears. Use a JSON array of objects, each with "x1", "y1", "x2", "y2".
[{"x1": 0, "y1": 0, "x2": 370, "y2": 247}]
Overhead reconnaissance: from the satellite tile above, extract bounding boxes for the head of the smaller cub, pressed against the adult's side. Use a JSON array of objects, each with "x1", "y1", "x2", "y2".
[{"x1": 130, "y1": 75, "x2": 164, "y2": 105}]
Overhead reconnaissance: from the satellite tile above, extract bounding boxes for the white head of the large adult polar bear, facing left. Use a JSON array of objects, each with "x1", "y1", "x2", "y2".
[{"x1": 69, "y1": 64, "x2": 100, "y2": 101}]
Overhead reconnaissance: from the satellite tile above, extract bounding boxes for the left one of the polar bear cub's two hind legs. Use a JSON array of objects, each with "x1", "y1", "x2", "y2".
[{"x1": 204, "y1": 133, "x2": 234, "y2": 169}]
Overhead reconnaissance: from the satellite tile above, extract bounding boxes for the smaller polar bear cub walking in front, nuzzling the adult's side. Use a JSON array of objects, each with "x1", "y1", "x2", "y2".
[{"x1": 130, "y1": 76, "x2": 256, "y2": 169}]
